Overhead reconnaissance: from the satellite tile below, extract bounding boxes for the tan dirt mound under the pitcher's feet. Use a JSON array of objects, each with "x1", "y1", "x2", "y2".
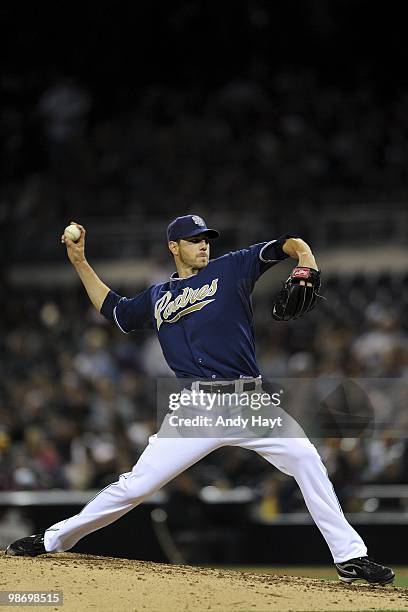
[{"x1": 0, "y1": 553, "x2": 408, "y2": 612}]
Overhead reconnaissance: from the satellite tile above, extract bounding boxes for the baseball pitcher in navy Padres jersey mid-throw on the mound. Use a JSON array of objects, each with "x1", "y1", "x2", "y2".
[{"x1": 6, "y1": 215, "x2": 394, "y2": 584}]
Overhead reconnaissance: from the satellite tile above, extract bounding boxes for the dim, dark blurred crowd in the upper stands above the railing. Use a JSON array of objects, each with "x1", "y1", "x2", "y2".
[{"x1": 0, "y1": 69, "x2": 408, "y2": 260}]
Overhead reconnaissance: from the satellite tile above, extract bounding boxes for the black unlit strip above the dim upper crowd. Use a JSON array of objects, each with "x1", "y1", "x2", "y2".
[{"x1": 1, "y1": 0, "x2": 407, "y2": 98}]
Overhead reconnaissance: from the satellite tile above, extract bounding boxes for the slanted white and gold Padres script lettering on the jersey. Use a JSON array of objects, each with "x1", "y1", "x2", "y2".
[{"x1": 154, "y1": 278, "x2": 218, "y2": 331}]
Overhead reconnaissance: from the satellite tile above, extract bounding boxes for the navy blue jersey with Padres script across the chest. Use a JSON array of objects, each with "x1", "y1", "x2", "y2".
[{"x1": 101, "y1": 241, "x2": 287, "y2": 380}]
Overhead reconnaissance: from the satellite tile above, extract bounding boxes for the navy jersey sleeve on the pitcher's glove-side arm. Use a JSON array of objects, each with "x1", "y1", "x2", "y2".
[{"x1": 231, "y1": 234, "x2": 294, "y2": 287}]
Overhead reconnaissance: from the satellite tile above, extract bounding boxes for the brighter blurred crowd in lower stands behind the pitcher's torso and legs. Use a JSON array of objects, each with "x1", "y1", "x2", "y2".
[{"x1": 0, "y1": 276, "x2": 408, "y2": 520}]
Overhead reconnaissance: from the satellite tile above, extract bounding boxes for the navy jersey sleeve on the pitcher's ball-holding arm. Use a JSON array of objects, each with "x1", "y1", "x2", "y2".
[{"x1": 101, "y1": 287, "x2": 153, "y2": 334}]
